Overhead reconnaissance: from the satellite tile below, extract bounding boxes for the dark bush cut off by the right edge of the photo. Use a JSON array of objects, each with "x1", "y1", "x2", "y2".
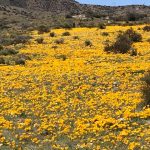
[{"x1": 142, "y1": 71, "x2": 150, "y2": 106}]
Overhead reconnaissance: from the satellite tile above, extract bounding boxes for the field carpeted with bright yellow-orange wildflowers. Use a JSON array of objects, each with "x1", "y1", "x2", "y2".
[{"x1": 0, "y1": 25, "x2": 150, "y2": 150}]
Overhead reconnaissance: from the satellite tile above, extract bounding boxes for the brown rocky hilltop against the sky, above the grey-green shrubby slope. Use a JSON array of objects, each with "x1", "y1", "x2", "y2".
[{"x1": 0, "y1": 0, "x2": 80, "y2": 12}]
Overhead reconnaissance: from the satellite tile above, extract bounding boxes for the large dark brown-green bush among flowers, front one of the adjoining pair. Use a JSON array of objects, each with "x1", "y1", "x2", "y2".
[{"x1": 104, "y1": 34, "x2": 132, "y2": 54}]
